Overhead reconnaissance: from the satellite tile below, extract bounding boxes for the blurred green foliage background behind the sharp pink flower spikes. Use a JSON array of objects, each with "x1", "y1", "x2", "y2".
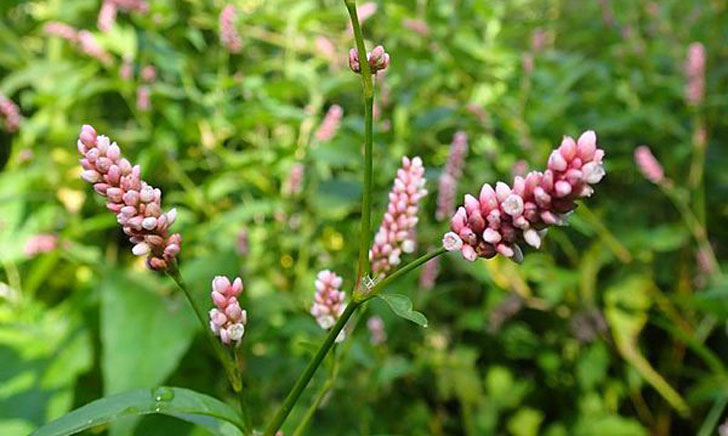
[{"x1": 0, "y1": 0, "x2": 728, "y2": 436}]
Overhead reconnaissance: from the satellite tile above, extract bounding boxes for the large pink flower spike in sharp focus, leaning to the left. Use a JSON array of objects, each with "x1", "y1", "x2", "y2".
[{"x1": 77, "y1": 125, "x2": 182, "y2": 270}]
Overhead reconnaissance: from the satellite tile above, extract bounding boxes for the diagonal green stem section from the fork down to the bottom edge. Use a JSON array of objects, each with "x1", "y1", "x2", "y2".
[{"x1": 264, "y1": 301, "x2": 361, "y2": 436}]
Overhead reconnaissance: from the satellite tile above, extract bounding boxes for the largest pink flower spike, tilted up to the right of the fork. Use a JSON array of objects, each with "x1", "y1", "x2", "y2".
[{"x1": 443, "y1": 130, "x2": 605, "y2": 262}]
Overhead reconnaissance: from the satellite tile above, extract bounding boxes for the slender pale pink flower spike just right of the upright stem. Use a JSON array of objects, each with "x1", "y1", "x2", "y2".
[{"x1": 369, "y1": 156, "x2": 427, "y2": 276}]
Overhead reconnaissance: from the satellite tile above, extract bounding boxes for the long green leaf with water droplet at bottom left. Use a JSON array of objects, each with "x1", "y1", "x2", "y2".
[{"x1": 33, "y1": 387, "x2": 243, "y2": 436}]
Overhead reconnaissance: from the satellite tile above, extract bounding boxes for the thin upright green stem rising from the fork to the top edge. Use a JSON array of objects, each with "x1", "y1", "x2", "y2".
[{"x1": 344, "y1": 0, "x2": 374, "y2": 295}]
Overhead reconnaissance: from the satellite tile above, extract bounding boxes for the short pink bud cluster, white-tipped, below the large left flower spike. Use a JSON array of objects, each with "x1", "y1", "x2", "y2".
[{"x1": 210, "y1": 276, "x2": 248, "y2": 346}]
